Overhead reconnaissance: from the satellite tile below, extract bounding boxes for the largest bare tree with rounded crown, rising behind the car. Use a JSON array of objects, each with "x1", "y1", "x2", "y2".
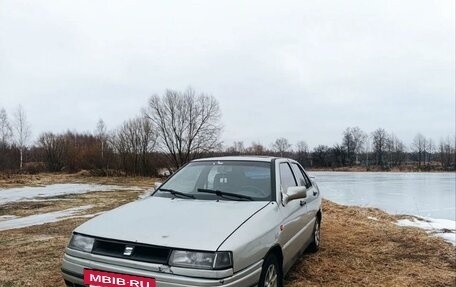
[{"x1": 144, "y1": 89, "x2": 222, "y2": 168}]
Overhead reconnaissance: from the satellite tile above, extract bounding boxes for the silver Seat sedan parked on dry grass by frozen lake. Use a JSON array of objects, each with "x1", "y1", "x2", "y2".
[{"x1": 62, "y1": 156, "x2": 322, "y2": 287}]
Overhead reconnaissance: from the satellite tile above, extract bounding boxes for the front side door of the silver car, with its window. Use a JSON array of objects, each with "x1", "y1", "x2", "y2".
[{"x1": 278, "y1": 161, "x2": 307, "y2": 270}]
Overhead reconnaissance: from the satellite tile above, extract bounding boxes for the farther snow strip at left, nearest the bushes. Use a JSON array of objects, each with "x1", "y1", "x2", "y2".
[{"x1": 0, "y1": 183, "x2": 143, "y2": 205}]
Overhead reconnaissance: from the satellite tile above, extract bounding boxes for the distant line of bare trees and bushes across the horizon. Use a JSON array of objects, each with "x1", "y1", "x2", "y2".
[{"x1": 0, "y1": 89, "x2": 456, "y2": 176}]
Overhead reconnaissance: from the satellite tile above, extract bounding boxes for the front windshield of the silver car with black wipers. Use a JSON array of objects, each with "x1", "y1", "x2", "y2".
[{"x1": 154, "y1": 161, "x2": 272, "y2": 201}]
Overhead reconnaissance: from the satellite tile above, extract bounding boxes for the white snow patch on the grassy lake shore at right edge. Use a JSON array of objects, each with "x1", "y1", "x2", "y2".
[{"x1": 396, "y1": 216, "x2": 456, "y2": 245}]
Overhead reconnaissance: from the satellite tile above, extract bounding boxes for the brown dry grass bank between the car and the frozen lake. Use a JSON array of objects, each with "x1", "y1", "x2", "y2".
[{"x1": 287, "y1": 201, "x2": 456, "y2": 287}]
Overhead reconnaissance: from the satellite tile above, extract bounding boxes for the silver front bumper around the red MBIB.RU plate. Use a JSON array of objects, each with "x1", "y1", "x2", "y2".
[{"x1": 62, "y1": 252, "x2": 263, "y2": 287}]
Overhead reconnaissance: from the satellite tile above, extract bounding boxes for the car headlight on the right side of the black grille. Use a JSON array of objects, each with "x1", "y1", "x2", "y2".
[{"x1": 169, "y1": 250, "x2": 233, "y2": 270}]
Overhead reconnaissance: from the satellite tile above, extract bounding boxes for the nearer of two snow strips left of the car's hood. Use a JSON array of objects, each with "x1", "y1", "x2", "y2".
[{"x1": 0, "y1": 205, "x2": 94, "y2": 231}]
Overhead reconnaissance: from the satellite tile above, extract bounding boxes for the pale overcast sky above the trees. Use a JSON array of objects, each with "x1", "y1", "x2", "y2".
[{"x1": 0, "y1": 0, "x2": 456, "y2": 147}]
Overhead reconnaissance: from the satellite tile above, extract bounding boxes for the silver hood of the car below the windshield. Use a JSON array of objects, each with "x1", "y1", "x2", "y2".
[{"x1": 75, "y1": 197, "x2": 268, "y2": 251}]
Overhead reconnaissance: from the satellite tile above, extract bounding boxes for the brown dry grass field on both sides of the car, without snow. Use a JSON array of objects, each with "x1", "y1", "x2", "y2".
[{"x1": 0, "y1": 174, "x2": 456, "y2": 287}]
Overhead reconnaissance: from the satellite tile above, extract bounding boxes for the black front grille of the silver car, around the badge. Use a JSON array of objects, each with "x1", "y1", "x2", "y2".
[{"x1": 92, "y1": 239, "x2": 171, "y2": 264}]
